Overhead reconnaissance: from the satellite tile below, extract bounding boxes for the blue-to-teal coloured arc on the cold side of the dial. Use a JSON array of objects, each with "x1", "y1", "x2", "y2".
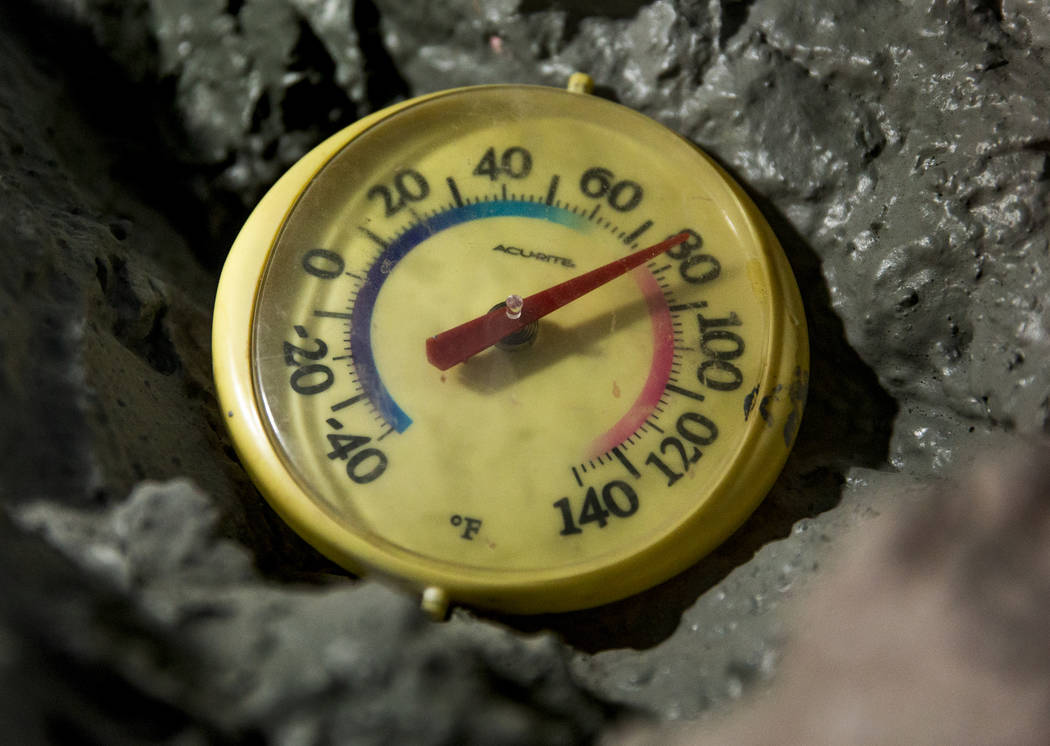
[{"x1": 350, "y1": 200, "x2": 592, "y2": 433}]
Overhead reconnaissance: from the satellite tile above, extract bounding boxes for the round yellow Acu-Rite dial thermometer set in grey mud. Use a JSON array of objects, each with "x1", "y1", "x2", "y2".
[{"x1": 213, "y1": 78, "x2": 807, "y2": 614}]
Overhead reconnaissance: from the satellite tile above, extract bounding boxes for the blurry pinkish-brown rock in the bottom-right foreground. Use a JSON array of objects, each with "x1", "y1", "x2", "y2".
[{"x1": 613, "y1": 442, "x2": 1050, "y2": 744}]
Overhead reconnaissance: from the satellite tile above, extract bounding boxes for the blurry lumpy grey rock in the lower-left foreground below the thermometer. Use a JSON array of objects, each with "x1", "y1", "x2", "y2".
[{"x1": 4, "y1": 481, "x2": 612, "y2": 744}]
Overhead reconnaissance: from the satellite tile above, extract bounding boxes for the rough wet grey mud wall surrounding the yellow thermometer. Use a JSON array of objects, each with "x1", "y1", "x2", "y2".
[{"x1": 0, "y1": 0, "x2": 1050, "y2": 745}]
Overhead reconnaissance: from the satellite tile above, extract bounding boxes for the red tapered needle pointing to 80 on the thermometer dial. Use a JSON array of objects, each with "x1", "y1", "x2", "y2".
[{"x1": 426, "y1": 233, "x2": 689, "y2": 371}]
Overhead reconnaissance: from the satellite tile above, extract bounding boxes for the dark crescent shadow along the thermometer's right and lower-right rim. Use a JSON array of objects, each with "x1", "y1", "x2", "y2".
[{"x1": 488, "y1": 175, "x2": 898, "y2": 654}]
